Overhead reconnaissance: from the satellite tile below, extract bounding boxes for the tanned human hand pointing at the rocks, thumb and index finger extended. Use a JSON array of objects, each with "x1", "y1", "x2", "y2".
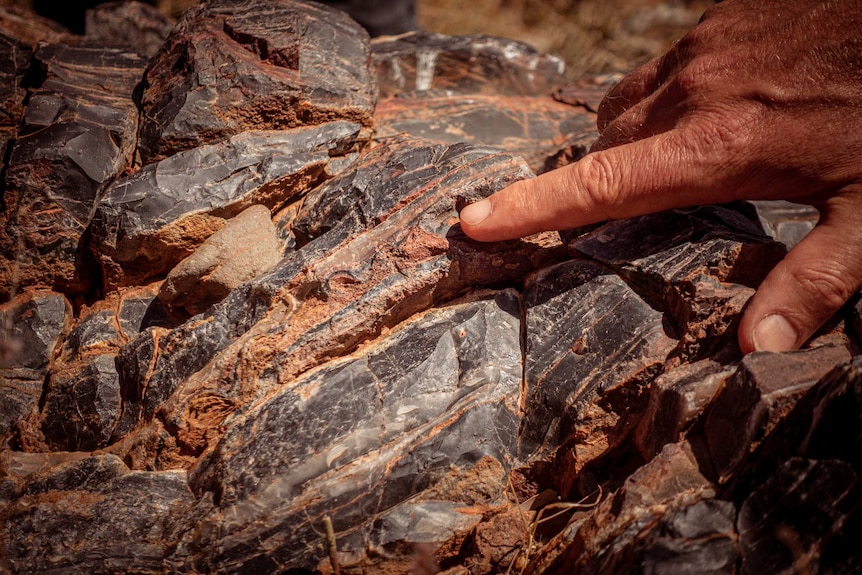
[{"x1": 461, "y1": 0, "x2": 862, "y2": 353}]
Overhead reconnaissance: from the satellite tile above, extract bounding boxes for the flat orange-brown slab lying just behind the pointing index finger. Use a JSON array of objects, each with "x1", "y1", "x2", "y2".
[{"x1": 374, "y1": 91, "x2": 598, "y2": 173}]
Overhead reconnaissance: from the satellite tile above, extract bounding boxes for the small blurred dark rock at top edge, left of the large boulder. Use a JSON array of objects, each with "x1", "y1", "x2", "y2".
[{"x1": 85, "y1": 1, "x2": 174, "y2": 58}]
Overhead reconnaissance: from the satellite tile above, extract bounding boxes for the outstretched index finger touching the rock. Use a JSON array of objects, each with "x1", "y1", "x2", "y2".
[{"x1": 461, "y1": 130, "x2": 737, "y2": 241}]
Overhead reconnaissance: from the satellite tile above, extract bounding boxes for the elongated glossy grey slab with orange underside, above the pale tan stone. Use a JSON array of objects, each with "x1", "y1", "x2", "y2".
[{"x1": 91, "y1": 122, "x2": 361, "y2": 289}]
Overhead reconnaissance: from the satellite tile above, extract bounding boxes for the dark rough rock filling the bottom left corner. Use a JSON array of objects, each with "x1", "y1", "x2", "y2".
[{"x1": 0, "y1": 456, "x2": 194, "y2": 575}]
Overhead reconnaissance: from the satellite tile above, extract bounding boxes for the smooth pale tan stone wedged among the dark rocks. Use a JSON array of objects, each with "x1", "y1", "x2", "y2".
[{"x1": 159, "y1": 204, "x2": 281, "y2": 315}]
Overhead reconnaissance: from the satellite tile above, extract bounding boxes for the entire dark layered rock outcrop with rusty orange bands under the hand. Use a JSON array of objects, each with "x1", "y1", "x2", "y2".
[{"x1": 0, "y1": 0, "x2": 862, "y2": 575}]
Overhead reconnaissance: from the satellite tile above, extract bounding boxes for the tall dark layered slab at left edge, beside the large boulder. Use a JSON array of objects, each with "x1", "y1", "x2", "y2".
[{"x1": 0, "y1": 44, "x2": 146, "y2": 294}]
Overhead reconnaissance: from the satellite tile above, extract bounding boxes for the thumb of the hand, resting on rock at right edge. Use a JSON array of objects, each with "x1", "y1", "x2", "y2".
[{"x1": 739, "y1": 196, "x2": 862, "y2": 353}]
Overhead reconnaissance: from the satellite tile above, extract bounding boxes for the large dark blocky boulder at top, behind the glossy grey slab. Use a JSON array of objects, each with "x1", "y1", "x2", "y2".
[{"x1": 139, "y1": 0, "x2": 377, "y2": 163}]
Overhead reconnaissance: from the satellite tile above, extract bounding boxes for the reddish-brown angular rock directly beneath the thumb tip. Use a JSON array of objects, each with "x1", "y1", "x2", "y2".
[{"x1": 704, "y1": 346, "x2": 850, "y2": 483}]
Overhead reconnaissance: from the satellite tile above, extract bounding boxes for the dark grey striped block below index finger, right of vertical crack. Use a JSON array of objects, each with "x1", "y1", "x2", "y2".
[{"x1": 520, "y1": 260, "x2": 677, "y2": 472}]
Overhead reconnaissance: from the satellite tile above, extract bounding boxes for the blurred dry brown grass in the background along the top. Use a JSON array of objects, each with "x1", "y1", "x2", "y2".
[{"x1": 0, "y1": 0, "x2": 712, "y2": 78}]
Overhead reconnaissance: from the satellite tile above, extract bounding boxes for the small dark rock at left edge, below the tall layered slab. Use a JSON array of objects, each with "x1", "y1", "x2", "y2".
[{"x1": 0, "y1": 291, "x2": 72, "y2": 437}]
